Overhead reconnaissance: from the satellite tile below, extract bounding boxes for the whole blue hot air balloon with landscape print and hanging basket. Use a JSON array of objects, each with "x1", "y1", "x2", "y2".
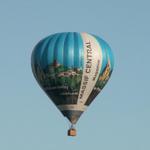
[{"x1": 31, "y1": 32, "x2": 114, "y2": 136}]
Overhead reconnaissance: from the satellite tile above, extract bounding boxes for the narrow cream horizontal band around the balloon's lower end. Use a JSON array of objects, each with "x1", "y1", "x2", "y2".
[{"x1": 57, "y1": 104, "x2": 87, "y2": 111}]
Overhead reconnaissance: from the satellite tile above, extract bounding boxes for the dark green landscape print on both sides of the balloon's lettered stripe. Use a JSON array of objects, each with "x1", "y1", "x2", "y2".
[{"x1": 36, "y1": 57, "x2": 112, "y2": 105}]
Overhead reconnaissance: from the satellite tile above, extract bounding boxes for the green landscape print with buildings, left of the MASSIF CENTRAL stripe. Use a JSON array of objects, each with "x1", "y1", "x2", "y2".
[{"x1": 36, "y1": 60, "x2": 83, "y2": 104}]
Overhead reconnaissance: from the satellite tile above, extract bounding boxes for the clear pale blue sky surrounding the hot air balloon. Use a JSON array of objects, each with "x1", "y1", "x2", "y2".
[{"x1": 0, "y1": 0, "x2": 150, "y2": 150}]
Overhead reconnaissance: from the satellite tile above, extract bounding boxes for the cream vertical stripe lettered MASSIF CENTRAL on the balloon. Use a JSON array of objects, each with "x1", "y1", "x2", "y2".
[{"x1": 77, "y1": 33, "x2": 102, "y2": 107}]
